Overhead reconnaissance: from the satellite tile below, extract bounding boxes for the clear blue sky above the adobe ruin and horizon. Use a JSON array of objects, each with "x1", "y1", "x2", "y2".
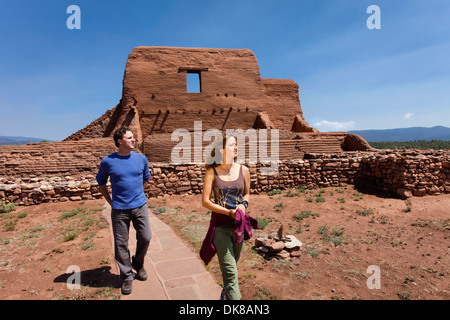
[{"x1": 0, "y1": 0, "x2": 450, "y2": 140}]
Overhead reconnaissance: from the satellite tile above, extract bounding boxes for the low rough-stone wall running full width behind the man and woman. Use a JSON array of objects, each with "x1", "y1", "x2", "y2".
[{"x1": 0, "y1": 151, "x2": 450, "y2": 205}]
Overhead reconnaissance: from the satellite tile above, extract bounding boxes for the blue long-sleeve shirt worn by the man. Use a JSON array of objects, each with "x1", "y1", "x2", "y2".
[{"x1": 96, "y1": 152, "x2": 150, "y2": 209}]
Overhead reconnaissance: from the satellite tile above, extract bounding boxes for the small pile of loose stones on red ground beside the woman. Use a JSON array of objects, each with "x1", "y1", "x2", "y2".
[{"x1": 255, "y1": 226, "x2": 303, "y2": 263}]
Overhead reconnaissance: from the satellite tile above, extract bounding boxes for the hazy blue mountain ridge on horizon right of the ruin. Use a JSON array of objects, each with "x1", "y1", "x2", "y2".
[{"x1": 348, "y1": 126, "x2": 450, "y2": 142}]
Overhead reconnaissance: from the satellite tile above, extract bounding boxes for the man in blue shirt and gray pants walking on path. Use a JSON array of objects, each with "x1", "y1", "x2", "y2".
[{"x1": 97, "y1": 127, "x2": 152, "y2": 294}]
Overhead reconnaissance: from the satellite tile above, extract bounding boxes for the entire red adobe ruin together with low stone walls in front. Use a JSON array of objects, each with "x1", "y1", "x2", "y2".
[{"x1": 0, "y1": 47, "x2": 450, "y2": 205}]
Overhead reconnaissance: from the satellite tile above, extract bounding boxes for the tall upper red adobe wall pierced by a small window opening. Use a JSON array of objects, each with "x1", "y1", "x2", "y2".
[{"x1": 121, "y1": 47, "x2": 301, "y2": 137}]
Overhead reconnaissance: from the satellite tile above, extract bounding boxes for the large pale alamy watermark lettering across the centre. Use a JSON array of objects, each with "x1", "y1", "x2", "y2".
[{"x1": 170, "y1": 121, "x2": 279, "y2": 175}]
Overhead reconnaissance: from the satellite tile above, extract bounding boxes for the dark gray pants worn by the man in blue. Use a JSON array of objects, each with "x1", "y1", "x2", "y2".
[{"x1": 111, "y1": 204, "x2": 152, "y2": 281}]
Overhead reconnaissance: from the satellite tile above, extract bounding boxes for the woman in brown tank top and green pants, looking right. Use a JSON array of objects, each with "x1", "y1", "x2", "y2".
[{"x1": 200, "y1": 134, "x2": 250, "y2": 300}]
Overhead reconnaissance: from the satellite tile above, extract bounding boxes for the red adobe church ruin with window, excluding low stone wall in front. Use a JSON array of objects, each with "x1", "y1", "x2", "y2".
[{"x1": 66, "y1": 47, "x2": 370, "y2": 161}]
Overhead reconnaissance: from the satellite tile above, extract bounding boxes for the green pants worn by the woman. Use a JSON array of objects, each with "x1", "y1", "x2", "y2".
[{"x1": 213, "y1": 227, "x2": 244, "y2": 300}]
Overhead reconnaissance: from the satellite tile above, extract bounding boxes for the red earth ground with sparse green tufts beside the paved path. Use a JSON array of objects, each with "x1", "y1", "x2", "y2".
[{"x1": 0, "y1": 186, "x2": 450, "y2": 300}]
